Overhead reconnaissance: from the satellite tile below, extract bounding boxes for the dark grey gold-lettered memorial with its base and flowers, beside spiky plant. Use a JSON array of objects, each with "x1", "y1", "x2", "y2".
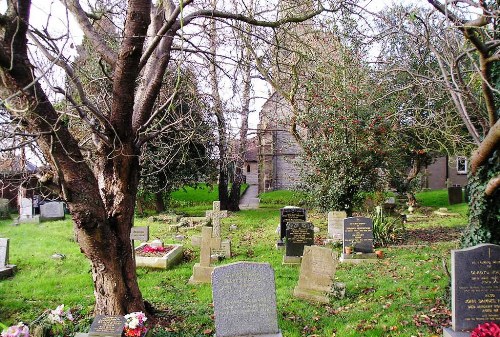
[{"x1": 340, "y1": 217, "x2": 377, "y2": 263}]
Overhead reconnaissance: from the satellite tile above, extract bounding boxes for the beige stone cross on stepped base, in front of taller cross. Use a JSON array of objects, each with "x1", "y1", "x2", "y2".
[{"x1": 188, "y1": 227, "x2": 221, "y2": 284}]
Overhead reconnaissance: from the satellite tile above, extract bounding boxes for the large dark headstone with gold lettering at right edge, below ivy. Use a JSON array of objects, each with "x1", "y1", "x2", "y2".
[{"x1": 443, "y1": 244, "x2": 500, "y2": 337}]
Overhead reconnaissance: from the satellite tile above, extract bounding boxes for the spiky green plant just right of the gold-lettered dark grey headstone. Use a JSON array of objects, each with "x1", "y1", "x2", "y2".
[{"x1": 372, "y1": 206, "x2": 406, "y2": 247}]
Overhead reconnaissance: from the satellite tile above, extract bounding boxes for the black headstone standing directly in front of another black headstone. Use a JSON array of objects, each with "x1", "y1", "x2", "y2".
[{"x1": 285, "y1": 221, "x2": 314, "y2": 256}]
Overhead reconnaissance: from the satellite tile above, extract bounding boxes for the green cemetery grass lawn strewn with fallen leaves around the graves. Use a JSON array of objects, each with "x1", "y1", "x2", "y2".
[{"x1": 0, "y1": 189, "x2": 466, "y2": 337}]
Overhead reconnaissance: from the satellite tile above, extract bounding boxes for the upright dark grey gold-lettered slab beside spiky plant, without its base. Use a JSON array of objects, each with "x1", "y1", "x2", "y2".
[{"x1": 343, "y1": 217, "x2": 373, "y2": 253}]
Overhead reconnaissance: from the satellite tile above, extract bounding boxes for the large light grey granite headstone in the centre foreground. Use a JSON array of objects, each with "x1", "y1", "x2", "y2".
[{"x1": 212, "y1": 262, "x2": 282, "y2": 337}]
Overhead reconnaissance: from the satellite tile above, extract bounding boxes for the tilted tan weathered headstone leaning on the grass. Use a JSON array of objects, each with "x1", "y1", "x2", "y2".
[{"x1": 293, "y1": 246, "x2": 338, "y2": 303}]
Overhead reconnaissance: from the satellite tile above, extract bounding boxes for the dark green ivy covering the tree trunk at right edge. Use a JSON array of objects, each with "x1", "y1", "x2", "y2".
[{"x1": 461, "y1": 150, "x2": 500, "y2": 247}]
